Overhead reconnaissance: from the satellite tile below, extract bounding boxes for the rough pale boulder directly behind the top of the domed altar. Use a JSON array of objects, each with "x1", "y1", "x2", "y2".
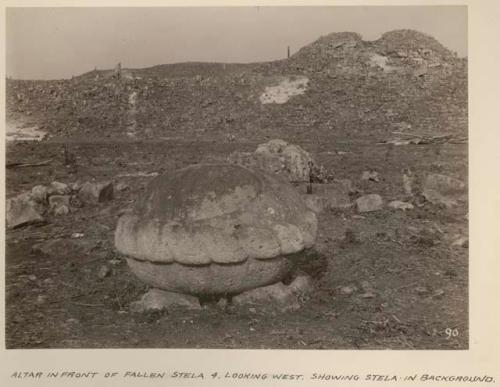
[{"x1": 228, "y1": 140, "x2": 314, "y2": 181}]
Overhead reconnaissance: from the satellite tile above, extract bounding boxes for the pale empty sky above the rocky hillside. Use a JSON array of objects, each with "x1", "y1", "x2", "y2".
[{"x1": 6, "y1": 6, "x2": 467, "y2": 79}]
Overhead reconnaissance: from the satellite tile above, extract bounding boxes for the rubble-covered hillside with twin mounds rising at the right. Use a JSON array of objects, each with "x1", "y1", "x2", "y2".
[{"x1": 7, "y1": 30, "x2": 467, "y2": 139}]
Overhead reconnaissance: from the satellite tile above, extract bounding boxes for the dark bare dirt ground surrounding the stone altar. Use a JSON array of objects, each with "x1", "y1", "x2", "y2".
[{"x1": 6, "y1": 138, "x2": 469, "y2": 349}]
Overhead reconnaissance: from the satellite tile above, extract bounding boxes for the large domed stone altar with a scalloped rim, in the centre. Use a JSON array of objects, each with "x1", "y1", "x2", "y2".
[{"x1": 115, "y1": 164, "x2": 317, "y2": 295}]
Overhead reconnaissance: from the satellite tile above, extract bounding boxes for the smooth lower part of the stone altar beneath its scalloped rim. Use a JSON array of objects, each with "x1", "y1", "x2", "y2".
[{"x1": 127, "y1": 257, "x2": 293, "y2": 296}]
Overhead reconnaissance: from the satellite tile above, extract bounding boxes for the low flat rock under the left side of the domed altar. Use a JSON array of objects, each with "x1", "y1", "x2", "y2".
[{"x1": 130, "y1": 289, "x2": 201, "y2": 313}]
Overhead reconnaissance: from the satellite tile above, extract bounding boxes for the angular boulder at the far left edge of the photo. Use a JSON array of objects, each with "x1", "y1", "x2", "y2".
[{"x1": 5, "y1": 194, "x2": 45, "y2": 228}]
